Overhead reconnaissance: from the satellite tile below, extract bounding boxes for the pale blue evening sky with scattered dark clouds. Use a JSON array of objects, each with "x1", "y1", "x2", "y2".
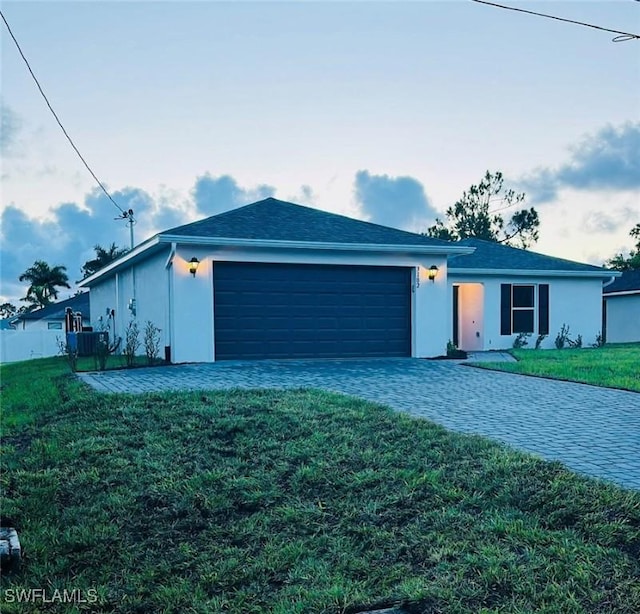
[{"x1": 0, "y1": 0, "x2": 640, "y2": 300}]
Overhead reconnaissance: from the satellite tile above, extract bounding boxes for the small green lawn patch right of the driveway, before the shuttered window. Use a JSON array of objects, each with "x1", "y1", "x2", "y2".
[{"x1": 477, "y1": 343, "x2": 640, "y2": 392}]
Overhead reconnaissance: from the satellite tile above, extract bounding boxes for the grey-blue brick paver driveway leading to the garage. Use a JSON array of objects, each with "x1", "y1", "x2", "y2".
[{"x1": 80, "y1": 358, "x2": 640, "y2": 489}]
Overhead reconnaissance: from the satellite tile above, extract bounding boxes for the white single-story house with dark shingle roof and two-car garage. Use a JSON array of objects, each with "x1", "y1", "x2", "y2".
[{"x1": 80, "y1": 198, "x2": 611, "y2": 362}]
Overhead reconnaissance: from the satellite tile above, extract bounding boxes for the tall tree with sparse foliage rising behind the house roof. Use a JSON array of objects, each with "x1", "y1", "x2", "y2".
[{"x1": 425, "y1": 171, "x2": 540, "y2": 249}]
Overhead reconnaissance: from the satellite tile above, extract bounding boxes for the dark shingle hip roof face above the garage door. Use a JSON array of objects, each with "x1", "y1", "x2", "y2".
[{"x1": 165, "y1": 198, "x2": 452, "y2": 247}]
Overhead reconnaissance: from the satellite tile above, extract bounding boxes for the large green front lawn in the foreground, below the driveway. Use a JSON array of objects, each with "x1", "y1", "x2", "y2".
[{"x1": 0, "y1": 359, "x2": 640, "y2": 614}]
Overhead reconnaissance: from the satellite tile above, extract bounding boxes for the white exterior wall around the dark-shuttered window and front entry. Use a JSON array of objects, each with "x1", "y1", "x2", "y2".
[{"x1": 449, "y1": 273, "x2": 602, "y2": 350}]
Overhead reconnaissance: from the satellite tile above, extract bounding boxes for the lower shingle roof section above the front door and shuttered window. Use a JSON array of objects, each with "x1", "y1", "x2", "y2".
[{"x1": 449, "y1": 239, "x2": 606, "y2": 272}]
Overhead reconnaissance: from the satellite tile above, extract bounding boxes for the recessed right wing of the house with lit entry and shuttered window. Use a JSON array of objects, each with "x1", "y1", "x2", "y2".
[{"x1": 448, "y1": 239, "x2": 619, "y2": 351}]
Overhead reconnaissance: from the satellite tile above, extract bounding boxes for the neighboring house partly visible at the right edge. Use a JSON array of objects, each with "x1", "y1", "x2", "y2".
[{"x1": 603, "y1": 270, "x2": 640, "y2": 343}]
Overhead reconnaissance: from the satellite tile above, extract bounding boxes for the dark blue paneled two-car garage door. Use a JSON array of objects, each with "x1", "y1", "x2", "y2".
[{"x1": 213, "y1": 262, "x2": 411, "y2": 360}]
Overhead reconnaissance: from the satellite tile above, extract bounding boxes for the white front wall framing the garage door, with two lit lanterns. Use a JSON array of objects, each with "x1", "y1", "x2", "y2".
[{"x1": 170, "y1": 245, "x2": 451, "y2": 362}]
